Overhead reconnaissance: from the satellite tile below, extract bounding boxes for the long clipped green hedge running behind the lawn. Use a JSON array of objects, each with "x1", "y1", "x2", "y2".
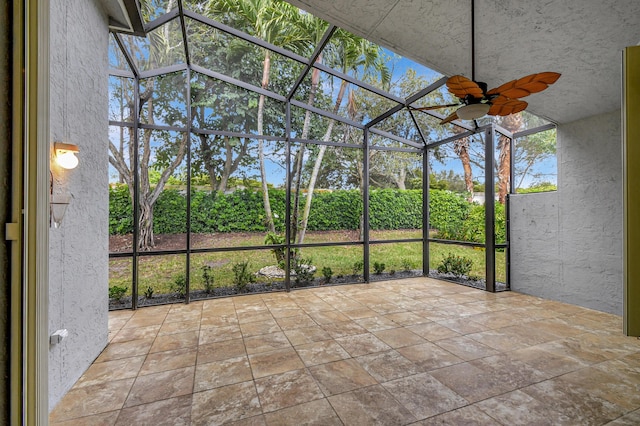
[{"x1": 109, "y1": 185, "x2": 480, "y2": 235}]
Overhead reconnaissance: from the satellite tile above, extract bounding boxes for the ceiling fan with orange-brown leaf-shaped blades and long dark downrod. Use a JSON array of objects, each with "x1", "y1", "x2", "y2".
[{"x1": 414, "y1": 0, "x2": 560, "y2": 124}]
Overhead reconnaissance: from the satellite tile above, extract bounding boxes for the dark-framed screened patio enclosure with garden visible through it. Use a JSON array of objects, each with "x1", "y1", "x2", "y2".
[{"x1": 109, "y1": 0, "x2": 554, "y2": 308}]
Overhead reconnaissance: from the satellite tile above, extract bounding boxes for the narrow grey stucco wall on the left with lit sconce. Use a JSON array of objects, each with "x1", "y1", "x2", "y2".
[{"x1": 49, "y1": 0, "x2": 108, "y2": 409}]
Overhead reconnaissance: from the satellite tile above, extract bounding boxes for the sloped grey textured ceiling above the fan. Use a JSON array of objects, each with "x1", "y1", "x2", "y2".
[{"x1": 287, "y1": 0, "x2": 640, "y2": 123}]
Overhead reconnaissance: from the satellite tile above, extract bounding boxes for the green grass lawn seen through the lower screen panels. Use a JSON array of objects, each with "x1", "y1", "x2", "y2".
[{"x1": 109, "y1": 230, "x2": 506, "y2": 295}]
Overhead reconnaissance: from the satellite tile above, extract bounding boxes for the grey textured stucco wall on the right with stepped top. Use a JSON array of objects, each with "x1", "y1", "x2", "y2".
[{"x1": 511, "y1": 110, "x2": 623, "y2": 314}]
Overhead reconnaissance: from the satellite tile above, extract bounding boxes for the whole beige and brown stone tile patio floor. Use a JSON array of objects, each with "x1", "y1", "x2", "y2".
[{"x1": 50, "y1": 278, "x2": 640, "y2": 426}]
